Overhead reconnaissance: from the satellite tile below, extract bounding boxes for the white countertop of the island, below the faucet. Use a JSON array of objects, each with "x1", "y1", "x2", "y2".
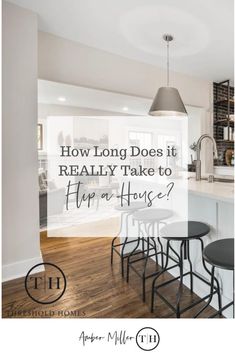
[{"x1": 188, "y1": 178, "x2": 234, "y2": 203}]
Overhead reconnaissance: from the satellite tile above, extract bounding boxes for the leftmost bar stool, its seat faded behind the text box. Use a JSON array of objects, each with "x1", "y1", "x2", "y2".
[{"x1": 111, "y1": 201, "x2": 147, "y2": 277}]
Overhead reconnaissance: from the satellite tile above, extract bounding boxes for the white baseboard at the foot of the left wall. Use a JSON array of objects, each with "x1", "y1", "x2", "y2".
[{"x1": 2, "y1": 254, "x2": 44, "y2": 282}]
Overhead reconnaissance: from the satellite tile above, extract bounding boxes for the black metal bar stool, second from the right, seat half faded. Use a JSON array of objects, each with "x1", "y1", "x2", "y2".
[{"x1": 151, "y1": 221, "x2": 221, "y2": 318}]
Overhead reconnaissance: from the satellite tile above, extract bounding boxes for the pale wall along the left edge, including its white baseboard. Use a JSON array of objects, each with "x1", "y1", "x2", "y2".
[{"x1": 2, "y1": 2, "x2": 41, "y2": 280}]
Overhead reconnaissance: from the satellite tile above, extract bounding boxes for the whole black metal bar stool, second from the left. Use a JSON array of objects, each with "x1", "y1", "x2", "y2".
[{"x1": 126, "y1": 208, "x2": 173, "y2": 302}]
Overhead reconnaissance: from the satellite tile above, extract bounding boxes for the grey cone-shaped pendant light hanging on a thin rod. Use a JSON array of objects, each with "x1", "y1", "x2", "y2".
[{"x1": 149, "y1": 34, "x2": 187, "y2": 116}]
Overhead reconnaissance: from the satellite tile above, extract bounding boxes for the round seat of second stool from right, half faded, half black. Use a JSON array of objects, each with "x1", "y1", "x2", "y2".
[{"x1": 161, "y1": 221, "x2": 210, "y2": 240}]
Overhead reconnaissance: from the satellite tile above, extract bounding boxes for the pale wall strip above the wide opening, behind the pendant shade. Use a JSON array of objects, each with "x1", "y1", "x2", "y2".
[{"x1": 38, "y1": 32, "x2": 212, "y2": 109}]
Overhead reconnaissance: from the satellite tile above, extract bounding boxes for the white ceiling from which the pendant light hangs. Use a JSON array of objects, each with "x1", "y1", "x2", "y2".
[{"x1": 6, "y1": 0, "x2": 234, "y2": 81}]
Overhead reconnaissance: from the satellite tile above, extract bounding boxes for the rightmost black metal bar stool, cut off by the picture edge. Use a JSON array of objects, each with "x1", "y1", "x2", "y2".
[{"x1": 195, "y1": 238, "x2": 234, "y2": 318}]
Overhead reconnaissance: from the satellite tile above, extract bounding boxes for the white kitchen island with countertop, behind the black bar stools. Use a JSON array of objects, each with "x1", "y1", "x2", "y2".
[{"x1": 185, "y1": 179, "x2": 234, "y2": 317}]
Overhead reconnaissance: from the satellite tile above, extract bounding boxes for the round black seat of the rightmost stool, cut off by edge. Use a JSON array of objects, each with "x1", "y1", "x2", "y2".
[{"x1": 203, "y1": 238, "x2": 234, "y2": 270}]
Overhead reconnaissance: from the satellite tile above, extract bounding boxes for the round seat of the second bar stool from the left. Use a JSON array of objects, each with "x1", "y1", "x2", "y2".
[{"x1": 133, "y1": 208, "x2": 173, "y2": 223}]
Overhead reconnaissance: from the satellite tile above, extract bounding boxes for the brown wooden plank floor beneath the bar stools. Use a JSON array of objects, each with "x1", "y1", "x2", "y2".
[{"x1": 2, "y1": 233, "x2": 218, "y2": 318}]
